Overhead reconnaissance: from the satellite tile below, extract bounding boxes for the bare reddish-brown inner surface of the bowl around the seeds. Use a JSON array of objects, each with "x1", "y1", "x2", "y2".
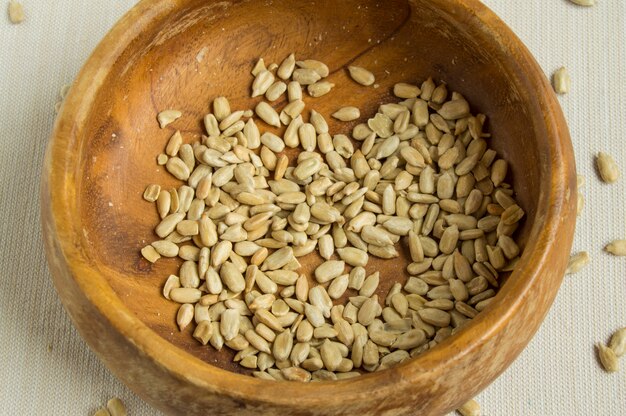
[{"x1": 75, "y1": 0, "x2": 541, "y2": 372}]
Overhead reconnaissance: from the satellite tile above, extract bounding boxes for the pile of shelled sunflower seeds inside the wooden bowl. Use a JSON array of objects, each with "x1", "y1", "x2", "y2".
[{"x1": 141, "y1": 54, "x2": 524, "y2": 382}]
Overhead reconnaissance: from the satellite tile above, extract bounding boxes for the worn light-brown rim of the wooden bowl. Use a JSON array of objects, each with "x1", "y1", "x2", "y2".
[{"x1": 41, "y1": 0, "x2": 576, "y2": 406}]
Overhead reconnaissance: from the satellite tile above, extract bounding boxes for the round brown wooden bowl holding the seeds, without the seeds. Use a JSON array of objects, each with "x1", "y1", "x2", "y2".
[{"x1": 41, "y1": 0, "x2": 576, "y2": 416}]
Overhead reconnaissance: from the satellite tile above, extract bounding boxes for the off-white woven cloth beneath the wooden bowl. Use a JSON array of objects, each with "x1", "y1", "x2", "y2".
[{"x1": 0, "y1": 0, "x2": 626, "y2": 416}]
